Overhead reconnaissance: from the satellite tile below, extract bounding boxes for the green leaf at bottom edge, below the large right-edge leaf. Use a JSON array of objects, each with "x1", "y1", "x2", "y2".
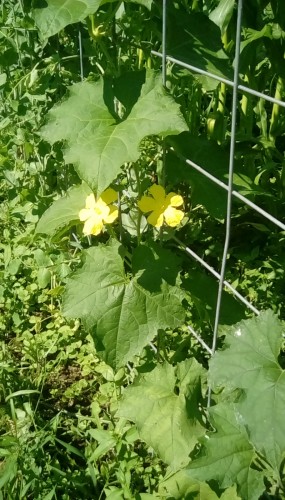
[{"x1": 185, "y1": 404, "x2": 264, "y2": 500}]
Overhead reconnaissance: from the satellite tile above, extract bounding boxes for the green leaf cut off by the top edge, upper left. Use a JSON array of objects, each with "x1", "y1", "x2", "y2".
[{"x1": 33, "y1": 0, "x2": 152, "y2": 39}]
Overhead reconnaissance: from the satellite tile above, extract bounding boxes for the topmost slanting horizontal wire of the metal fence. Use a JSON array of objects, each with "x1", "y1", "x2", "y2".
[{"x1": 151, "y1": 50, "x2": 285, "y2": 108}]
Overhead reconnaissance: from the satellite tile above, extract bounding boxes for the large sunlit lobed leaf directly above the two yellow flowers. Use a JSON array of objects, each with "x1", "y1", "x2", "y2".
[{"x1": 42, "y1": 72, "x2": 187, "y2": 194}]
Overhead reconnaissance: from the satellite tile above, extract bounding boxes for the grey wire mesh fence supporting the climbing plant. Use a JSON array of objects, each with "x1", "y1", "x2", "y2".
[{"x1": 152, "y1": 0, "x2": 285, "y2": 378}]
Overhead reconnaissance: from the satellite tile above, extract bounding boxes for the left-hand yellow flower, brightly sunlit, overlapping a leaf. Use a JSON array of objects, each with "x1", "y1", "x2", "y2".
[{"x1": 79, "y1": 188, "x2": 118, "y2": 236}]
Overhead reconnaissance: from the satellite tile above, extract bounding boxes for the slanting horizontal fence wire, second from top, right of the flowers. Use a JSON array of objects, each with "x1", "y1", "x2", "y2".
[{"x1": 171, "y1": 148, "x2": 285, "y2": 231}]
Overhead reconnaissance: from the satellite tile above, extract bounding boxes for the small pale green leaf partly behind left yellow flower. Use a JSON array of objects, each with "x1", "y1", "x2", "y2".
[{"x1": 36, "y1": 183, "x2": 91, "y2": 236}]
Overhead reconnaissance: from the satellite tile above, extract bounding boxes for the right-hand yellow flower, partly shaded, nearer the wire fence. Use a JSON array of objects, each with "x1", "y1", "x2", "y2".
[{"x1": 138, "y1": 184, "x2": 184, "y2": 227}]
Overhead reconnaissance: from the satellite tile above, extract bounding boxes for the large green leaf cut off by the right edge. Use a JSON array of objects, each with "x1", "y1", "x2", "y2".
[{"x1": 210, "y1": 311, "x2": 285, "y2": 469}]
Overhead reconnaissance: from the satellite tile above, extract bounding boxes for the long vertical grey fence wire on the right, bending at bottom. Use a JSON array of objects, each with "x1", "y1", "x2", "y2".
[{"x1": 205, "y1": 0, "x2": 242, "y2": 406}]
